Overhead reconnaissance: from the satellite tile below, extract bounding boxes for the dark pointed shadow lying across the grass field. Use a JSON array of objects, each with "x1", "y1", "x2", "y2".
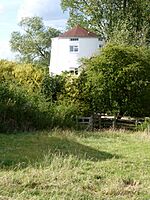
[{"x1": 0, "y1": 135, "x2": 119, "y2": 169}]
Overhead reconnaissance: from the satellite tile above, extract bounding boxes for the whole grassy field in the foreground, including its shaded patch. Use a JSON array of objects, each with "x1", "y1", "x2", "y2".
[{"x1": 0, "y1": 131, "x2": 150, "y2": 200}]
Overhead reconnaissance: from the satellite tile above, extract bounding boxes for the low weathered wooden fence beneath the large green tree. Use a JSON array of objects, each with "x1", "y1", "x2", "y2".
[{"x1": 77, "y1": 115, "x2": 144, "y2": 130}]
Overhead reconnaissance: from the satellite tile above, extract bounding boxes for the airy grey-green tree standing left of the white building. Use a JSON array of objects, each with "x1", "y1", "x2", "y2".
[{"x1": 10, "y1": 17, "x2": 60, "y2": 66}]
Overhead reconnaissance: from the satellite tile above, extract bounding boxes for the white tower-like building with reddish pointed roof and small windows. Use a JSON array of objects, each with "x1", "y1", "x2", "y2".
[{"x1": 49, "y1": 26, "x2": 103, "y2": 75}]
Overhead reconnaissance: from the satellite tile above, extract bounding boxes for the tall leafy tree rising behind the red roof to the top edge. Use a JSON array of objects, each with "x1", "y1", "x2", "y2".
[{"x1": 61, "y1": 0, "x2": 150, "y2": 39}]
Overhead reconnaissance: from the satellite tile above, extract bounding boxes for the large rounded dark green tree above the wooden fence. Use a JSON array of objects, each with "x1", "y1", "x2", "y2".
[{"x1": 79, "y1": 44, "x2": 150, "y2": 117}]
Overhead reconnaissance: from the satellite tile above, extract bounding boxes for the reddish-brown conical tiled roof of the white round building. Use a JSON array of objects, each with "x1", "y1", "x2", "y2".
[{"x1": 59, "y1": 25, "x2": 98, "y2": 38}]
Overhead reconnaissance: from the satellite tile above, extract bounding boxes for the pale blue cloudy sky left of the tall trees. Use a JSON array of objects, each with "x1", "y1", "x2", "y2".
[{"x1": 0, "y1": 0, "x2": 67, "y2": 59}]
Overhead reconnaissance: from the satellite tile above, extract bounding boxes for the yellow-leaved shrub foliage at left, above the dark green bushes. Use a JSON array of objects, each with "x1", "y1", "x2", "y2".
[{"x1": 0, "y1": 60, "x2": 46, "y2": 93}]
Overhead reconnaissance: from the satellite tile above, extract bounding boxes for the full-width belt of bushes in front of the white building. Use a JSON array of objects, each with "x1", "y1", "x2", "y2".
[{"x1": 0, "y1": 44, "x2": 150, "y2": 131}]
